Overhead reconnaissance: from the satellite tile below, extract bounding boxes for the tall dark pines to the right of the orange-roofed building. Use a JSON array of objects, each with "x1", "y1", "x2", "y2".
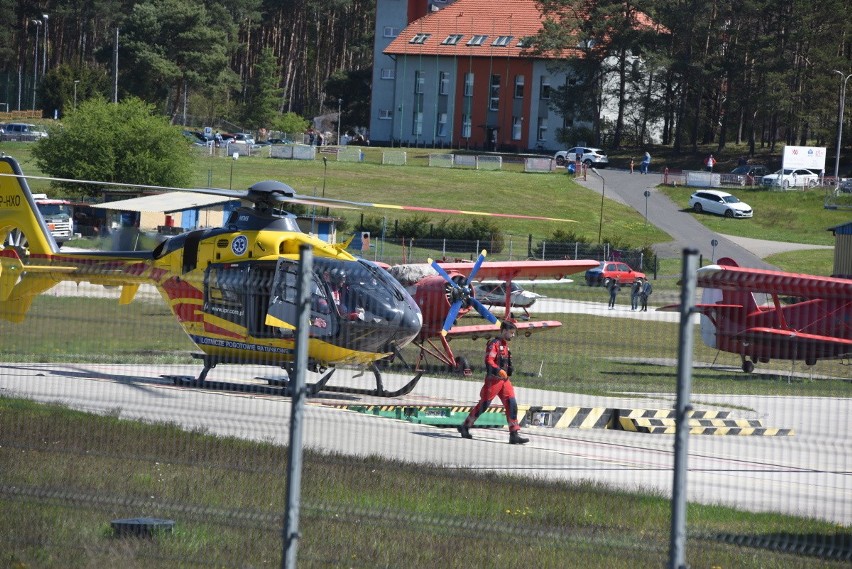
[{"x1": 533, "y1": 0, "x2": 852, "y2": 158}]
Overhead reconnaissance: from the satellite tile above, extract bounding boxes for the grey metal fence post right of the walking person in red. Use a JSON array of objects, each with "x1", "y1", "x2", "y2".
[{"x1": 668, "y1": 249, "x2": 698, "y2": 569}]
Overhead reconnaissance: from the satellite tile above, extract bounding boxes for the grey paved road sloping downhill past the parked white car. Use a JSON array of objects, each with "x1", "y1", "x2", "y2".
[{"x1": 576, "y1": 169, "x2": 833, "y2": 269}]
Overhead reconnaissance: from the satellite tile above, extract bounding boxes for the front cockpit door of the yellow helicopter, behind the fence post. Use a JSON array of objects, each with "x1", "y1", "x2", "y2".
[{"x1": 266, "y1": 259, "x2": 339, "y2": 337}]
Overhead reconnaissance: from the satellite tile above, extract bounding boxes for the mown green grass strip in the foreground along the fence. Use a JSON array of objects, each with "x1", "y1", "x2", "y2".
[{"x1": 0, "y1": 398, "x2": 849, "y2": 569}]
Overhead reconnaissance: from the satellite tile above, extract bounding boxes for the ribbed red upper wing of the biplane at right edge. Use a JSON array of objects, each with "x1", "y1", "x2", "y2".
[{"x1": 697, "y1": 265, "x2": 852, "y2": 299}]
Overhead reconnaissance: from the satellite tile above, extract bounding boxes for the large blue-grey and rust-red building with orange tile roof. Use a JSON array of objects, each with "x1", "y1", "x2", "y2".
[{"x1": 370, "y1": 0, "x2": 664, "y2": 152}]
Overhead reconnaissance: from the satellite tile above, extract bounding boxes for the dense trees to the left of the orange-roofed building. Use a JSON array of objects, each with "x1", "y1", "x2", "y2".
[{"x1": 0, "y1": 0, "x2": 375, "y2": 128}]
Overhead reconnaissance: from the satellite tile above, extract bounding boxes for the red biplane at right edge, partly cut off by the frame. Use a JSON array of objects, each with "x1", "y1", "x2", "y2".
[{"x1": 659, "y1": 258, "x2": 852, "y2": 373}]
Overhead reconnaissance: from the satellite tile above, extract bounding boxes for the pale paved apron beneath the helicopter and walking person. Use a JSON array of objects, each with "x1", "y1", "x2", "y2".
[{"x1": 0, "y1": 364, "x2": 852, "y2": 525}]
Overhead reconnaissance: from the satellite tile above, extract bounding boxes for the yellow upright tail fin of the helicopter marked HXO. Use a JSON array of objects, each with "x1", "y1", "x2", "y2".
[{"x1": 0, "y1": 156, "x2": 59, "y2": 255}]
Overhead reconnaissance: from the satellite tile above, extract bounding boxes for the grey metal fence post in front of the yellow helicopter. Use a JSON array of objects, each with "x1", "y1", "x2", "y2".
[{"x1": 281, "y1": 244, "x2": 314, "y2": 569}]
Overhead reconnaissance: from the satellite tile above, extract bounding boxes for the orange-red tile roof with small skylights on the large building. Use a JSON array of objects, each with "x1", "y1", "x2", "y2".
[{"x1": 385, "y1": 0, "x2": 560, "y2": 57}]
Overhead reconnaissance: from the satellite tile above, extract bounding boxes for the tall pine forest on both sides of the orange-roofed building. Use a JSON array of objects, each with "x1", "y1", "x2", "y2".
[{"x1": 0, "y1": 0, "x2": 852, "y2": 160}]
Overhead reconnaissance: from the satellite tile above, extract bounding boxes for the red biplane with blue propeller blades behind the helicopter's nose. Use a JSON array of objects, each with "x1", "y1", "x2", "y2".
[{"x1": 388, "y1": 251, "x2": 598, "y2": 375}]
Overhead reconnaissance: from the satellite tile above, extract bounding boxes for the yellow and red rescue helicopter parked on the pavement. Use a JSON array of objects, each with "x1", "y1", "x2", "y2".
[{"x1": 0, "y1": 156, "x2": 568, "y2": 397}]
